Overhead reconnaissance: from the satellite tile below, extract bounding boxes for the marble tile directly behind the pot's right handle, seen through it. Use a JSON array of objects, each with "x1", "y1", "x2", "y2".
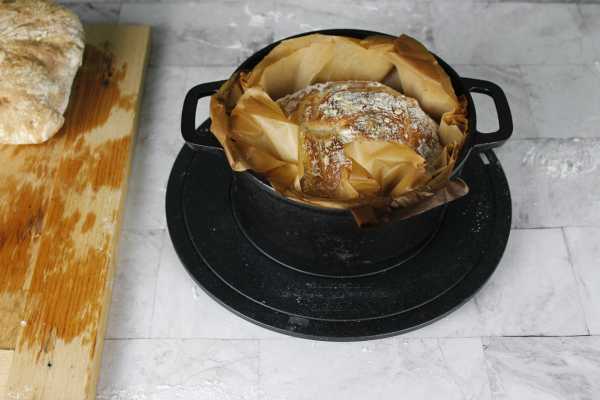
[{"x1": 454, "y1": 65, "x2": 543, "y2": 138}]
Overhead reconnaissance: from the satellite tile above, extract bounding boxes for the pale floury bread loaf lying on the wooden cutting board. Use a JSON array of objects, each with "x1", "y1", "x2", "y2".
[{"x1": 0, "y1": 0, "x2": 84, "y2": 144}]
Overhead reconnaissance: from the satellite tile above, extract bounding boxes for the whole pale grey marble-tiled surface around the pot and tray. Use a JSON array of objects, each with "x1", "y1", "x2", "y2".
[{"x1": 59, "y1": 0, "x2": 600, "y2": 400}]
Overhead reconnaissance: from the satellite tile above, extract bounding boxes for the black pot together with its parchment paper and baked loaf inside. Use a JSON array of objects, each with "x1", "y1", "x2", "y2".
[{"x1": 182, "y1": 30, "x2": 512, "y2": 275}]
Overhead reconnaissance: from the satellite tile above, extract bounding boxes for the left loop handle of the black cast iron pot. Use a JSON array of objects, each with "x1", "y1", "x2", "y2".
[{"x1": 181, "y1": 81, "x2": 226, "y2": 153}]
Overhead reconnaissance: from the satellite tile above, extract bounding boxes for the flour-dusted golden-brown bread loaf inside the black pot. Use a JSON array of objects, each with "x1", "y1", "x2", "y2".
[{"x1": 277, "y1": 81, "x2": 441, "y2": 198}]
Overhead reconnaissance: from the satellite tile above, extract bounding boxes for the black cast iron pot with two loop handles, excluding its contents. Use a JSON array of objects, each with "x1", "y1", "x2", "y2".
[{"x1": 181, "y1": 29, "x2": 513, "y2": 277}]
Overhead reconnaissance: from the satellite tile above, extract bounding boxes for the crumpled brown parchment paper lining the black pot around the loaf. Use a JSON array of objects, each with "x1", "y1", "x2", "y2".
[{"x1": 210, "y1": 34, "x2": 468, "y2": 223}]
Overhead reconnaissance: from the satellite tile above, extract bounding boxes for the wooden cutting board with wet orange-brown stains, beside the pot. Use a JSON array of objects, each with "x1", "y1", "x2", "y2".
[{"x1": 0, "y1": 25, "x2": 150, "y2": 400}]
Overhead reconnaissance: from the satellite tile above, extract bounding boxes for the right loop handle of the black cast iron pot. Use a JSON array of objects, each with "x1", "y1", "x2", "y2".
[{"x1": 461, "y1": 78, "x2": 513, "y2": 151}]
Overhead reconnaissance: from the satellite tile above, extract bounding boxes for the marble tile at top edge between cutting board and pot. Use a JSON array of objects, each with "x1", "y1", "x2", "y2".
[{"x1": 120, "y1": 0, "x2": 275, "y2": 66}]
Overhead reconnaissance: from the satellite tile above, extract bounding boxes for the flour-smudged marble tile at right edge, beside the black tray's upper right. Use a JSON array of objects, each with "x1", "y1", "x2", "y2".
[{"x1": 496, "y1": 139, "x2": 600, "y2": 228}]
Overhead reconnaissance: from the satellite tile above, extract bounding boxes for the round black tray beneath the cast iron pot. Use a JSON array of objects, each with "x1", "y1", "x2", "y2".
[{"x1": 166, "y1": 147, "x2": 511, "y2": 341}]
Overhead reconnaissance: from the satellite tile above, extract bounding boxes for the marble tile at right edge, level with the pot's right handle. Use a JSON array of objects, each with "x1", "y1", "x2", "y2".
[{"x1": 521, "y1": 63, "x2": 600, "y2": 138}]
